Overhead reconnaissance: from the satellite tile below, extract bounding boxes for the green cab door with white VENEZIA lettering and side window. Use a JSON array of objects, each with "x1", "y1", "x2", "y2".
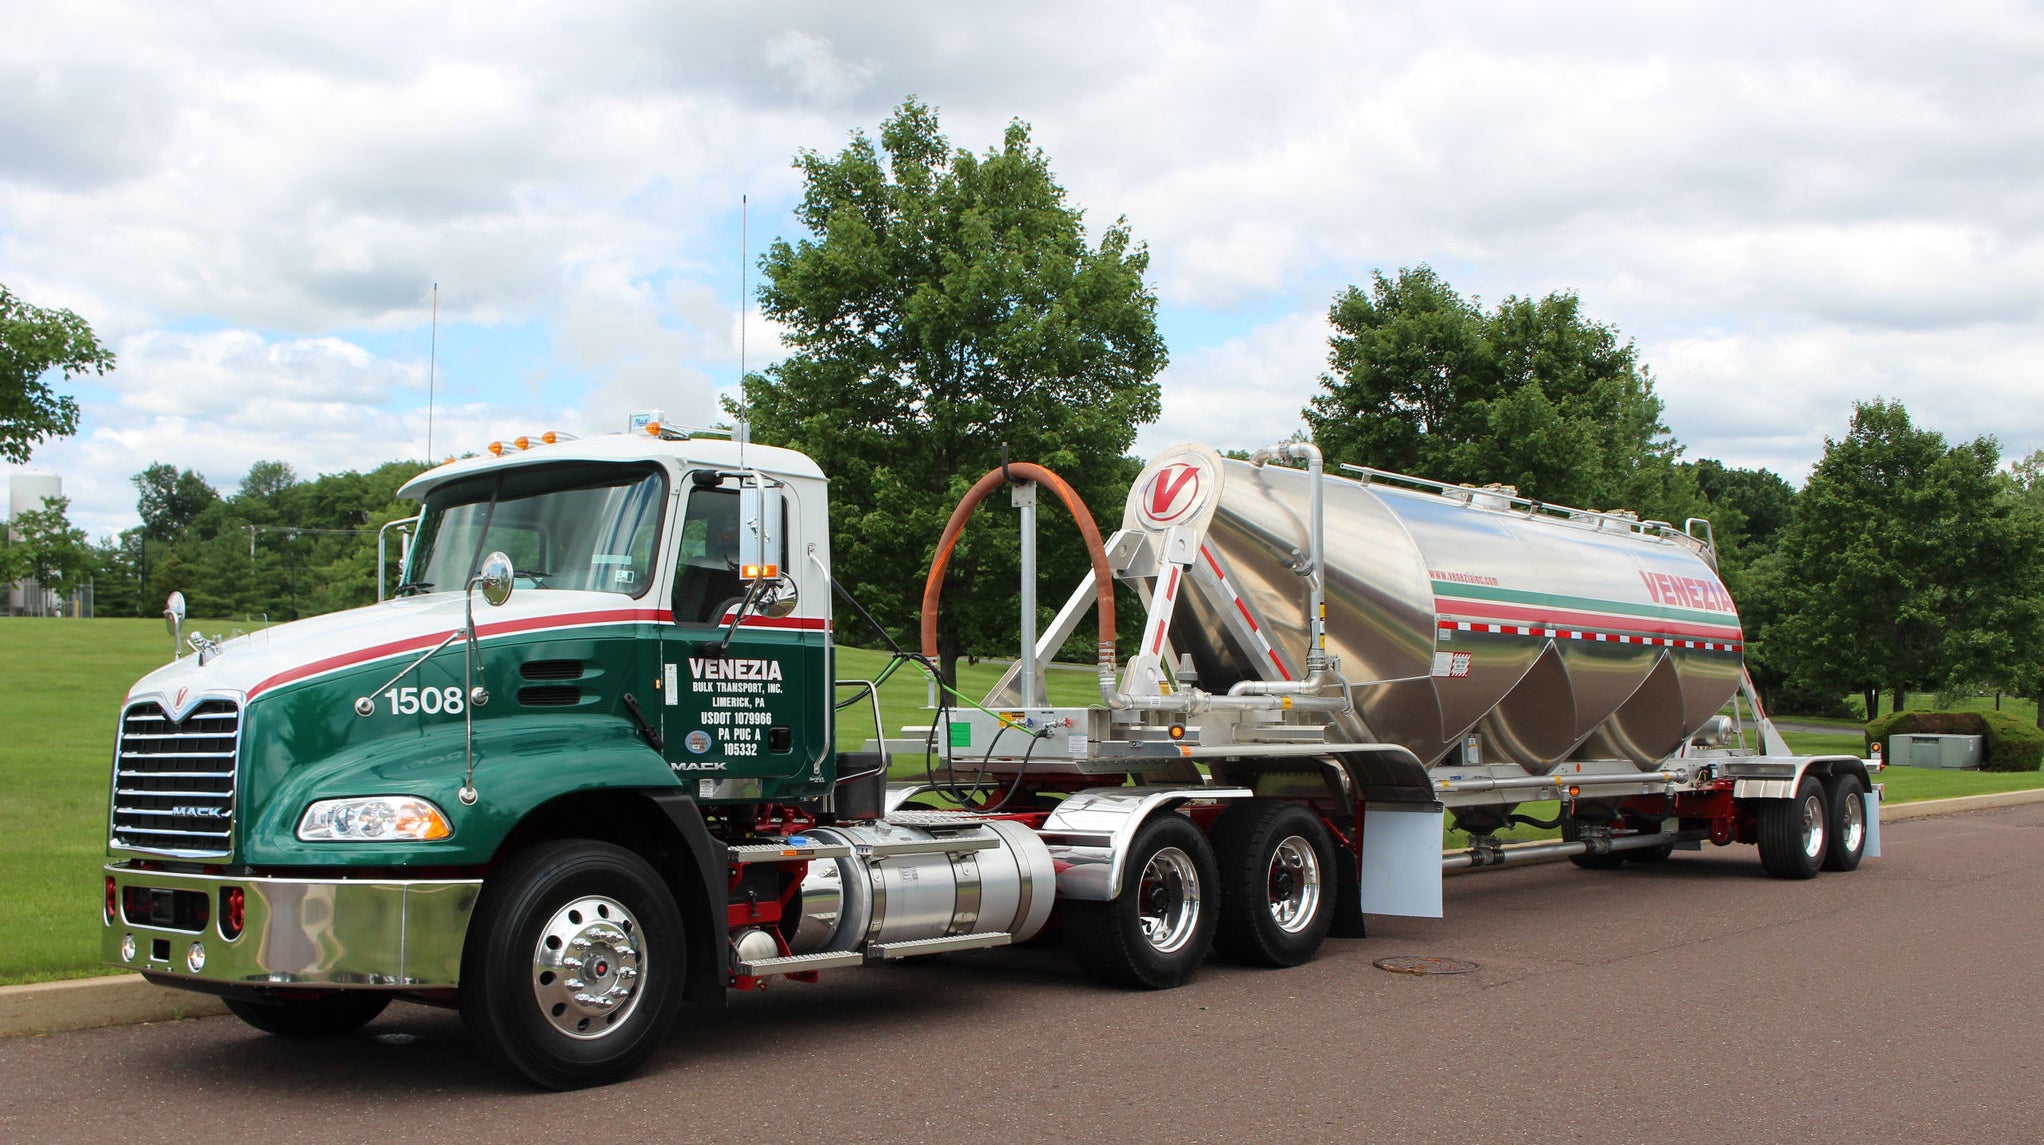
[{"x1": 660, "y1": 474, "x2": 826, "y2": 799}]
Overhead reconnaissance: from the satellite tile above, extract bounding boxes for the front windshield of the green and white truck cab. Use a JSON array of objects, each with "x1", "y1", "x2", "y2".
[{"x1": 401, "y1": 462, "x2": 666, "y2": 597}]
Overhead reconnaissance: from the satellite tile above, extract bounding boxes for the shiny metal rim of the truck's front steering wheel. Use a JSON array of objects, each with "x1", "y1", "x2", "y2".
[{"x1": 531, "y1": 896, "x2": 646, "y2": 1041}]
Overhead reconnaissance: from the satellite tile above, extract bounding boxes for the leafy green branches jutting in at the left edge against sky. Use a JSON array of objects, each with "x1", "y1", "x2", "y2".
[{"x1": 0, "y1": 286, "x2": 114, "y2": 462}]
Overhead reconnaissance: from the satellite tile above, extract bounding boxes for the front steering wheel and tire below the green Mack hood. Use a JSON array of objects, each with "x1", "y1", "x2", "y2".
[{"x1": 460, "y1": 838, "x2": 687, "y2": 1090}]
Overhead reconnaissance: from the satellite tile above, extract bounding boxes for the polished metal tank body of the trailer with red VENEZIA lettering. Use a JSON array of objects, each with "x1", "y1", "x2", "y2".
[{"x1": 1124, "y1": 446, "x2": 1744, "y2": 771}]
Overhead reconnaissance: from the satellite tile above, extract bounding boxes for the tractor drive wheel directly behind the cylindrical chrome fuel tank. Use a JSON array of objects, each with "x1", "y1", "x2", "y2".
[{"x1": 1061, "y1": 812, "x2": 1220, "y2": 990}]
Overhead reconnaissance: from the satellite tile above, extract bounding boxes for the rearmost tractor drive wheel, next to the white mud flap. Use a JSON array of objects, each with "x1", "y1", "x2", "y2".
[{"x1": 1208, "y1": 799, "x2": 1337, "y2": 967}]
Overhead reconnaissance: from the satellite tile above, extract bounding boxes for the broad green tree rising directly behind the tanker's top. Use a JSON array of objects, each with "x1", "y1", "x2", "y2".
[{"x1": 1304, "y1": 266, "x2": 1705, "y2": 521}]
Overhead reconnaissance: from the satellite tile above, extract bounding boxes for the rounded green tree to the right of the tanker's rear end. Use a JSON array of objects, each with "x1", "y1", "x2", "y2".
[{"x1": 1762, "y1": 399, "x2": 2036, "y2": 718}]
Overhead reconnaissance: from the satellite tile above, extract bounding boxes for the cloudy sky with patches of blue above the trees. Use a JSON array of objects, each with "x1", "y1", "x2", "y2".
[{"x1": 0, "y1": 0, "x2": 2044, "y2": 536}]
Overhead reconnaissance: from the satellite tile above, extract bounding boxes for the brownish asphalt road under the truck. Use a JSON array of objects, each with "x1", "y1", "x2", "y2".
[{"x1": 0, "y1": 806, "x2": 2044, "y2": 1145}]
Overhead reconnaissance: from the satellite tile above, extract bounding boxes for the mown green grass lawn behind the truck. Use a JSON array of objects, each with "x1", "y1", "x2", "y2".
[{"x1": 0, "y1": 617, "x2": 2044, "y2": 986}]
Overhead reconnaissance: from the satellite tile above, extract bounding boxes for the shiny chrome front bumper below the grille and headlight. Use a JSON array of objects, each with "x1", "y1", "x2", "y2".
[{"x1": 100, "y1": 863, "x2": 482, "y2": 990}]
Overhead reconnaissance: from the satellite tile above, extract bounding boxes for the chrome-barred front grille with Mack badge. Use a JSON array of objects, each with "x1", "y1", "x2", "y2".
[{"x1": 110, "y1": 699, "x2": 241, "y2": 855}]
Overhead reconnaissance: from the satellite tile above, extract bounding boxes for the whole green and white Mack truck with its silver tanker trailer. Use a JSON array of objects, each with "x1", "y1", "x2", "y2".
[{"x1": 102, "y1": 419, "x2": 1880, "y2": 1088}]
